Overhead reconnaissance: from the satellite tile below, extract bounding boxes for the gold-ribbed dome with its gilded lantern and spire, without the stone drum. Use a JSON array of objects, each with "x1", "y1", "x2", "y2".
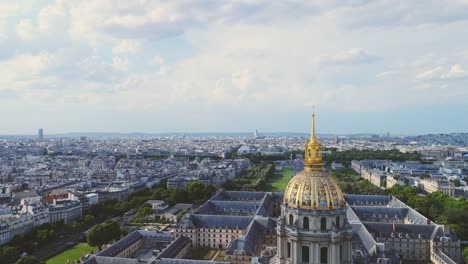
[{"x1": 284, "y1": 113, "x2": 345, "y2": 210}]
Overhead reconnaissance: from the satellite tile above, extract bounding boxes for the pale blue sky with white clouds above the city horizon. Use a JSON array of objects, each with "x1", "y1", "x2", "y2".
[{"x1": 0, "y1": 0, "x2": 468, "y2": 134}]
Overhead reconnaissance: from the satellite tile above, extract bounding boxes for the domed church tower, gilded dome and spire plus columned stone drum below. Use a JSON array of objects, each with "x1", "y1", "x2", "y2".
[{"x1": 277, "y1": 113, "x2": 352, "y2": 264}]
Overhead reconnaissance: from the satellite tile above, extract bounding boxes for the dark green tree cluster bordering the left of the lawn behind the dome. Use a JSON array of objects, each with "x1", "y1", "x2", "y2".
[{"x1": 223, "y1": 163, "x2": 275, "y2": 191}]
